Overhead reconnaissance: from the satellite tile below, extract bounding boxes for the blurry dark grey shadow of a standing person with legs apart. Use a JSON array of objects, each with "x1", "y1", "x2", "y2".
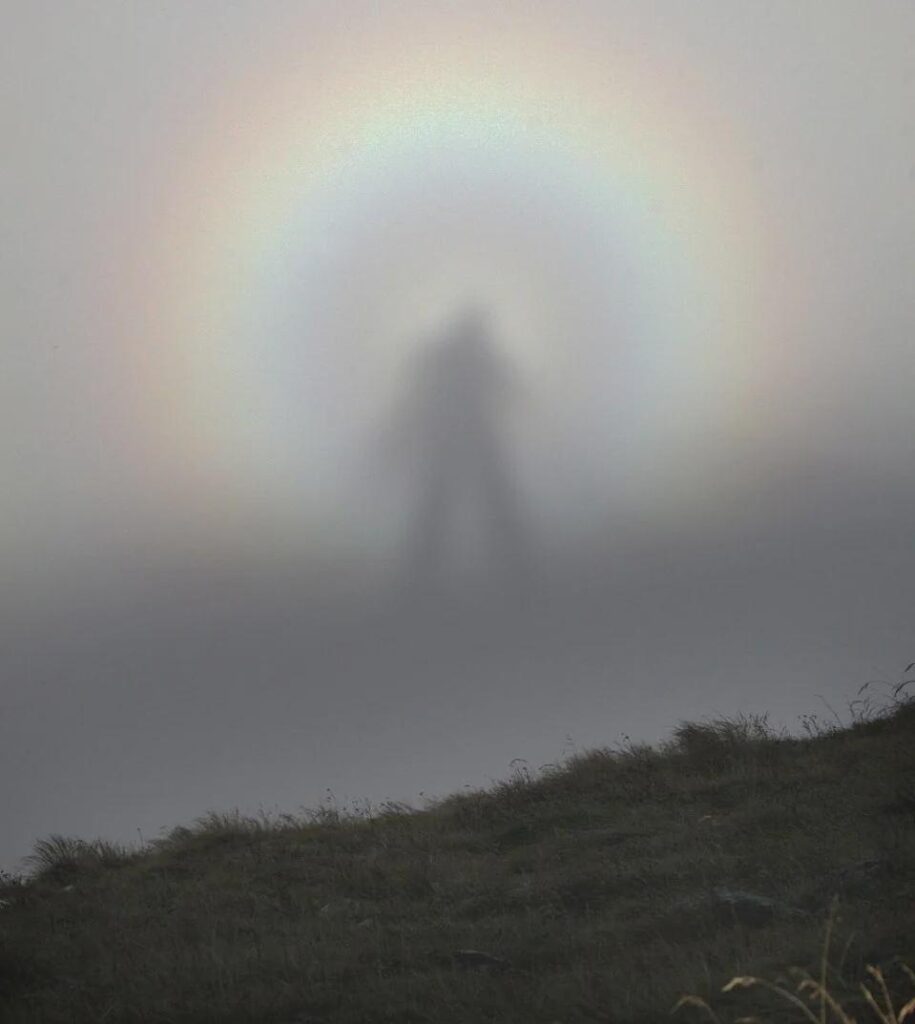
[{"x1": 386, "y1": 308, "x2": 527, "y2": 587}]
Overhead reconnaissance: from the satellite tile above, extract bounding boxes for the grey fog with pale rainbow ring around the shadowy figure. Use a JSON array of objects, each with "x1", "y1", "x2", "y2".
[{"x1": 0, "y1": 0, "x2": 915, "y2": 865}]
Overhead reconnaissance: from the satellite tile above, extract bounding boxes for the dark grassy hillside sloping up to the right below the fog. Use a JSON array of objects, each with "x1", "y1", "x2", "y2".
[{"x1": 0, "y1": 694, "x2": 915, "y2": 1024}]
